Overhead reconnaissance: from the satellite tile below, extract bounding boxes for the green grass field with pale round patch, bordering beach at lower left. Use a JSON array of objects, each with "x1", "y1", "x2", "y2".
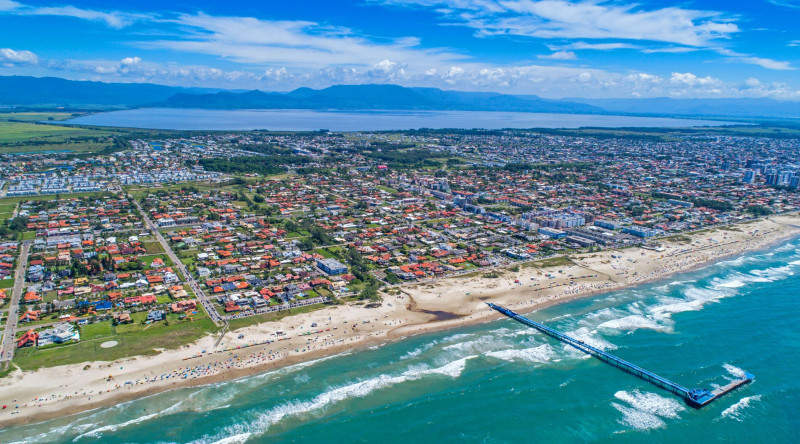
[{"x1": 14, "y1": 309, "x2": 217, "y2": 370}]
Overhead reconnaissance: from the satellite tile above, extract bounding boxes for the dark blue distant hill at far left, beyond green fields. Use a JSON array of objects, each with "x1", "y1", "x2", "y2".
[{"x1": 0, "y1": 76, "x2": 219, "y2": 107}]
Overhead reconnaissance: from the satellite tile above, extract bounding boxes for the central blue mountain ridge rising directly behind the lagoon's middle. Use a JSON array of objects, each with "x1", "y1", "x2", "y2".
[{"x1": 152, "y1": 85, "x2": 603, "y2": 114}]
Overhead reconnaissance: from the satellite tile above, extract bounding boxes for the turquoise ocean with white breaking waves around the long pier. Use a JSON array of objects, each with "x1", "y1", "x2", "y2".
[{"x1": 0, "y1": 240, "x2": 800, "y2": 443}]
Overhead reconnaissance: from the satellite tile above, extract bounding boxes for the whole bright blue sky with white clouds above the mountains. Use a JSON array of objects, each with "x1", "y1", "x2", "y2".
[{"x1": 0, "y1": 0, "x2": 800, "y2": 100}]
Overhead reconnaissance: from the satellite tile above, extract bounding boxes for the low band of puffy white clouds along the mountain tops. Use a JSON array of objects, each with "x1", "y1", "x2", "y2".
[{"x1": 29, "y1": 53, "x2": 800, "y2": 100}]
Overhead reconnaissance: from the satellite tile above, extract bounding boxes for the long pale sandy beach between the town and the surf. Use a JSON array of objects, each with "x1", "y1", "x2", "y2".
[{"x1": 0, "y1": 214, "x2": 800, "y2": 427}]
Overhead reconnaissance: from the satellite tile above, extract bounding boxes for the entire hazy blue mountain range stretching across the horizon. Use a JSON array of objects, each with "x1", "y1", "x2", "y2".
[{"x1": 0, "y1": 76, "x2": 800, "y2": 118}]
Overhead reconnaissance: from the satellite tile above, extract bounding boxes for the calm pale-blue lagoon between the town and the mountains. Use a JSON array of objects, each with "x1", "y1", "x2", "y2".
[{"x1": 67, "y1": 108, "x2": 733, "y2": 131}]
